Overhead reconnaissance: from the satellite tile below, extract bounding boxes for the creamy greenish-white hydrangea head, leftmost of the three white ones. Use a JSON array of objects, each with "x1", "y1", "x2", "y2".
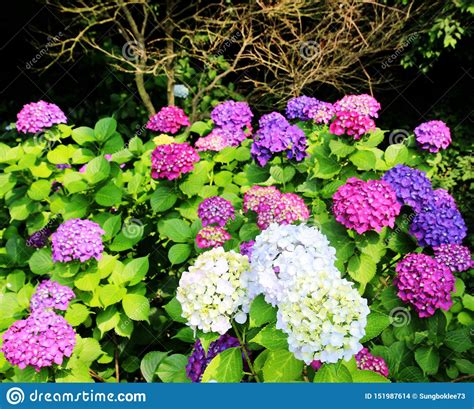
[{"x1": 176, "y1": 247, "x2": 250, "y2": 334}]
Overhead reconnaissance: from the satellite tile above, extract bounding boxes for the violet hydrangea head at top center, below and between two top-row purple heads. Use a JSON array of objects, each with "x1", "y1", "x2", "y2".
[{"x1": 251, "y1": 112, "x2": 308, "y2": 166}]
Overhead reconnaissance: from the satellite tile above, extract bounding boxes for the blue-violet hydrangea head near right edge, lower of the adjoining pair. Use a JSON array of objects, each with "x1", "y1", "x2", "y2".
[{"x1": 410, "y1": 204, "x2": 467, "y2": 247}]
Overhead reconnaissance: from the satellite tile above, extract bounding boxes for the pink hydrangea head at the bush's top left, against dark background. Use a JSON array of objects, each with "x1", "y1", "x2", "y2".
[{"x1": 16, "y1": 101, "x2": 67, "y2": 133}]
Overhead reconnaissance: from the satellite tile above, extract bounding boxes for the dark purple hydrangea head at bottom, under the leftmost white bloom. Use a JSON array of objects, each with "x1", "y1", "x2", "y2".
[{"x1": 186, "y1": 334, "x2": 240, "y2": 382}]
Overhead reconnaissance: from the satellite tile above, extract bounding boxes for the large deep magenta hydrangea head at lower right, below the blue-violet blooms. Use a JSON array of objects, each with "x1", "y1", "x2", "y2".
[{"x1": 393, "y1": 253, "x2": 455, "y2": 318}]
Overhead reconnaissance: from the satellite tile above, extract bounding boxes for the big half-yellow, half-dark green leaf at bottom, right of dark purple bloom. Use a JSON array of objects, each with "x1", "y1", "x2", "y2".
[{"x1": 202, "y1": 348, "x2": 244, "y2": 383}]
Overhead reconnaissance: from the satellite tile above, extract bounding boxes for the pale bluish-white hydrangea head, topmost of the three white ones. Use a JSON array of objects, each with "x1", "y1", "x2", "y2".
[{"x1": 249, "y1": 224, "x2": 340, "y2": 306}]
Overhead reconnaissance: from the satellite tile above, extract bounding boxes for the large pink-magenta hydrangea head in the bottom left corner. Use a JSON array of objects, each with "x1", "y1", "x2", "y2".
[{"x1": 1, "y1": 311, "x2": 76, "y2": 371}]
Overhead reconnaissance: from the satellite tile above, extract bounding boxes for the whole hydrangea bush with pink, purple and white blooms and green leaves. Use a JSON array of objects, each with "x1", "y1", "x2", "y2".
[{"x1": 0, "y1": 95, "x2": 474, "y2": 382}]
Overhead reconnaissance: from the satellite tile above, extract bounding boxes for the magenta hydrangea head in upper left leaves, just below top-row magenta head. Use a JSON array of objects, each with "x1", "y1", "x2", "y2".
[{"x1": 151, "y1": 142, "x2": 200, "y2": 180}]
